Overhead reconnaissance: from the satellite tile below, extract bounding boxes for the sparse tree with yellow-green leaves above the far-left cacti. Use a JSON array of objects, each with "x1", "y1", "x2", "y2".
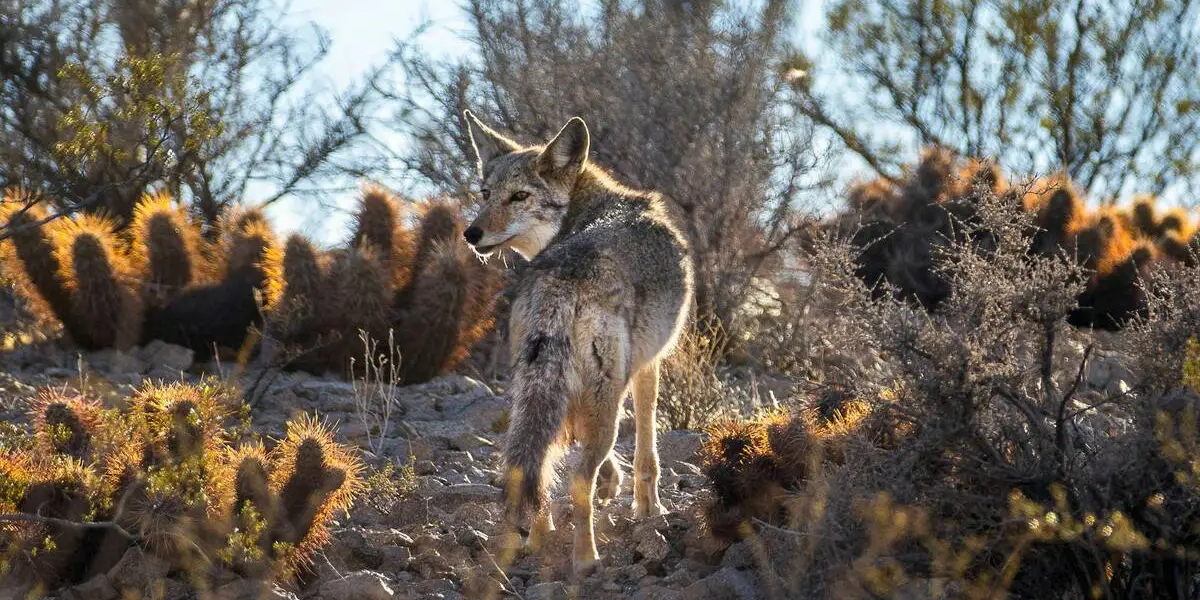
[{"x1": 0, "y1": 0, "x2": 381, "y2": 221}]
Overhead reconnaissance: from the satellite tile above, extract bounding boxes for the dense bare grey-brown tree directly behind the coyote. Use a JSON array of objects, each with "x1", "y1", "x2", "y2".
[{"x1": 379, "y1": 0, "x2": 823, "y2": 333}]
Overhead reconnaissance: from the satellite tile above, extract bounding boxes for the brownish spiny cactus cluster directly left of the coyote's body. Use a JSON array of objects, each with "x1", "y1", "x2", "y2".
[{"x1": 268, "y1": 186, "x2": 500, "y2": 383}]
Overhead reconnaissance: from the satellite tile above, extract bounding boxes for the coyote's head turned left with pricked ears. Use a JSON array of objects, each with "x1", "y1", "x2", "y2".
[{"x1": 463, "y1": 110, "x2": 589, "y2": 259}]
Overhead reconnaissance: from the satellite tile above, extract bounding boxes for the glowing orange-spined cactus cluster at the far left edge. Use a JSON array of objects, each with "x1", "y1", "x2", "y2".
[{"x1": 0, "y1": 190, "x2": 278, "y2": 359}]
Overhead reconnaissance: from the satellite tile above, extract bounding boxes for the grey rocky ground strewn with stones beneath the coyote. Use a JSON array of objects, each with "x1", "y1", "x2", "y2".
[{"x1": 0, "y1": 343, "x2": 760, "y2": 600}]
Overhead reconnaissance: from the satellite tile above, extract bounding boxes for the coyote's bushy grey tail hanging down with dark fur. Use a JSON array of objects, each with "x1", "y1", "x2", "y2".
[{"x1": 504, "y1": 288, "x2": 578, "y2": 520}]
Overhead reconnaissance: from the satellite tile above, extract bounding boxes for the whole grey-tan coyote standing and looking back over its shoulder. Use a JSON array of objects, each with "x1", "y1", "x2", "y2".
[{"x1": 463, "y1": 110, "x2": 692, "y2": 572}]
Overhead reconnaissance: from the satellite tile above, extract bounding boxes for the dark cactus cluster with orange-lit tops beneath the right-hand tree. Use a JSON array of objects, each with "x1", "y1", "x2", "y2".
[{"x1": 826, "y1": 148, "x2": 1200, "y2": 330}]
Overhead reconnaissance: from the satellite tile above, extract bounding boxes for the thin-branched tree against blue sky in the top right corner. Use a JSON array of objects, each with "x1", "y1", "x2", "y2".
[{"x1": 796, "y1": 0, "x2": 1200, "y2": 200}]
